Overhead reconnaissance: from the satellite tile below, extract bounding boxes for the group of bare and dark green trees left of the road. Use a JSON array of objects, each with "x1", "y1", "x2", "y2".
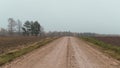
[{"x1": 0, "y1": 18, "x2": 44, "y2": 36}]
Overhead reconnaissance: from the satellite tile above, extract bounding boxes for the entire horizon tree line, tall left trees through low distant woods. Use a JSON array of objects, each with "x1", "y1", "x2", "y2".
[{"x1": 0, "y1": 18, "x2": 83, "y2": 37}]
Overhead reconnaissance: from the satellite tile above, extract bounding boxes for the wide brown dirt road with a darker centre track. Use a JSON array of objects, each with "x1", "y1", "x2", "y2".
[{"x1": 2, "y1": 37, "x2": 120, "y2": 68}]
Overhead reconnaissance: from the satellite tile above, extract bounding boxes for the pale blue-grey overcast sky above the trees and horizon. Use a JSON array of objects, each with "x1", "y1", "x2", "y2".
[{"x1": 0, "y1": 0, "x2": 120, "y2": 34}]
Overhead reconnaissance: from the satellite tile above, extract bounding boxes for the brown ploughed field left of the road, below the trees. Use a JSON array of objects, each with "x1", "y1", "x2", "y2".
[{"x1": 0, "y1": 36, "x2": 44, "y2": 54}]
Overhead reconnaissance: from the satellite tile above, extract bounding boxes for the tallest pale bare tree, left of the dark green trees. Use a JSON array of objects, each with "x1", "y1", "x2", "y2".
[{"x1": 8, "y1": 18, "x2": 17, "y2": 35}]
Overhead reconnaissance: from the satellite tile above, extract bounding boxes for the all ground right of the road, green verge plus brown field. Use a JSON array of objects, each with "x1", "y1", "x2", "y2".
[{"x1": 81, "y1": 37, "x2": 120, "y2": 60}]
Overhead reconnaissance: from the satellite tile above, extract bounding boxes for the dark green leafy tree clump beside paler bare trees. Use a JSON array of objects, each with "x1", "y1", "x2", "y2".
[{"x1": 22, "y1": 21, "x2": 41, "y2": 36}]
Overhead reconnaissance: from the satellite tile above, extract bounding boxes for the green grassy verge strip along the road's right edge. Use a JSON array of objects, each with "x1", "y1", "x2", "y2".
[{"x1": 80, "y1": 37, "x2": 120, "y2": 61}]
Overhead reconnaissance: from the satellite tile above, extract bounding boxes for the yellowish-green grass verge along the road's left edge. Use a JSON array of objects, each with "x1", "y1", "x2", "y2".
[{"x1": 0, "y1": 38, "x2": 57, "y2": 66}]
